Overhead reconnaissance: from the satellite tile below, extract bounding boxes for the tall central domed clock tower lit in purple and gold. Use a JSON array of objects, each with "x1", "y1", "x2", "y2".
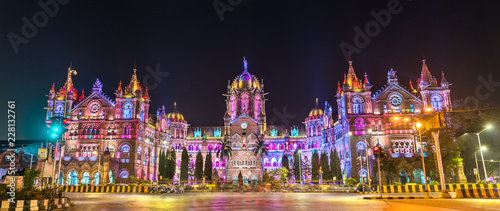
[{"x1": 224, "y1": 58, "x2": 267, "y2": 182}]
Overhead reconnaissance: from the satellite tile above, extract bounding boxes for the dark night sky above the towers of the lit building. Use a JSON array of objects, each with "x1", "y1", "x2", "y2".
[{"x1": 0, "y1": 0, "x2": 500, "y2": 140}]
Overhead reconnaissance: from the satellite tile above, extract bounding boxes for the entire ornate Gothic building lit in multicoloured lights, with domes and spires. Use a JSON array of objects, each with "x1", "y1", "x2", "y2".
[{"x1": 47, "y1": 59, "x2": 451, "y2": 185}]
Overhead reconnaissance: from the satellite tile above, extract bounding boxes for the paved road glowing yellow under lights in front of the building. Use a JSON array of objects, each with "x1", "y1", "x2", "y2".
[{"x1": 65, "y1": 193, "x2": 500, "y2": 211}]
